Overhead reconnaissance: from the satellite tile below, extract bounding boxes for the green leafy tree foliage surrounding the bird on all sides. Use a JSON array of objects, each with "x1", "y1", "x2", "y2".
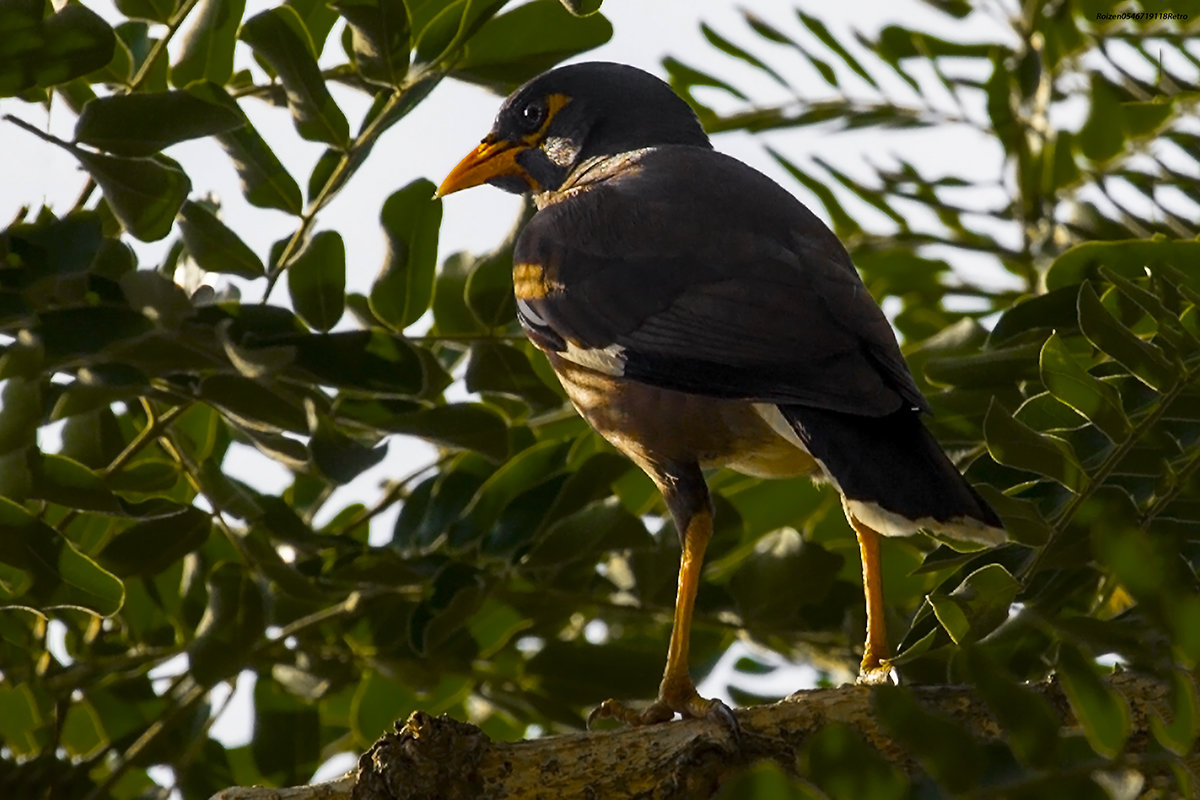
[{"x1": 0, "y1": 0, "x2": 1200, "y2": 798}]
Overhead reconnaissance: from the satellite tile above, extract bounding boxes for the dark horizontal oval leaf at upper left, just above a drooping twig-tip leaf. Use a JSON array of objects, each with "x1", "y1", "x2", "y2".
[{"x1": 74, "y1": 90, "x2": 242, "y2": 157}]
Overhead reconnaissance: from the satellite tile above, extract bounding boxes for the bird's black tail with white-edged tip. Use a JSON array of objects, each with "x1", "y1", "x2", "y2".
[{"x1": 779, "y1": 404, "x2": 1007, "y2": 545}]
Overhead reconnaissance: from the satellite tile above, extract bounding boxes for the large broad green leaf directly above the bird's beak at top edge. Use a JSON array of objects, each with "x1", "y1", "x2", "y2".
[{"x1": 450, "y1": 0, "x2": 612, "y2": 94}]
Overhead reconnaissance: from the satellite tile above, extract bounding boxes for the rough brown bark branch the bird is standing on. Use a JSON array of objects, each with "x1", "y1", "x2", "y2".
[{"x1": 214, "y1": 673, "x2": 1200, "y2": 800}]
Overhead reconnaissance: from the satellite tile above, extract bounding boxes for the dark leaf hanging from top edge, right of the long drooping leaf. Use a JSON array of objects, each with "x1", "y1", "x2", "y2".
[{"x1": 329, "y1": 0, "x2": 410, "y2": 88}]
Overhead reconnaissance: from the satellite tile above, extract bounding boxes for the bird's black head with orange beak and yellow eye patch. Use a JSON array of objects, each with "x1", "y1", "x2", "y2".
[{"x1": 438, "y1": 61, "x2": 712, "y2": 197}]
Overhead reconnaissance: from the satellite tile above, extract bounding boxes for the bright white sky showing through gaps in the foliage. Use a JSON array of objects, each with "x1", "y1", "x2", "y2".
[{"x1": 0, "y1": 0, "x2": 1032, "y2": 777}]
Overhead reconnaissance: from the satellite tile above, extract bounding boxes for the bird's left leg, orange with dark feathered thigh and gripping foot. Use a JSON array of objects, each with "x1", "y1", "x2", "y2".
[{"x1": 588, "y1": 464, "x2": 738, "y2": 732}]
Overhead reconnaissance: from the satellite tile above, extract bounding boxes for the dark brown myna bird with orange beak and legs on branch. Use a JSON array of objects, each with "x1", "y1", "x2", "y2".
[{"x1": 437, "y1": 61, "x2": 1006, "y2": 726}]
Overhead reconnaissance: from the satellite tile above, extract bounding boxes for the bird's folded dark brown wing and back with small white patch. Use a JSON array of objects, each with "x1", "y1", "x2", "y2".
[{"x1": 514, "y1": 146, "x2": 925, "y2": 416}]
